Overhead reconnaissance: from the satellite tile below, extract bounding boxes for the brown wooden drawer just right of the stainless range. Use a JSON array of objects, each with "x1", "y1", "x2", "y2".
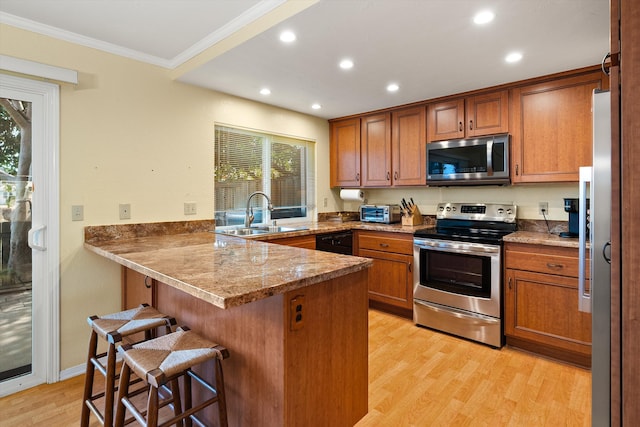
[{"x1": 505, "y1": 244, "x2": 589, "y2": 277}]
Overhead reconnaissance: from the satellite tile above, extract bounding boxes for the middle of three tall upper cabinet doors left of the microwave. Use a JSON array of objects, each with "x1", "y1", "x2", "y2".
[{"x1": 361, "y1": 113, "x2": 391, "y2": 187}]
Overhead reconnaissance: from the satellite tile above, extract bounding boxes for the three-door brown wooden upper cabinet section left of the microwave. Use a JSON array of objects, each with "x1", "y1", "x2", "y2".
[{"x1": 330, "y1": 106, "x2": 426, "y2": 187}]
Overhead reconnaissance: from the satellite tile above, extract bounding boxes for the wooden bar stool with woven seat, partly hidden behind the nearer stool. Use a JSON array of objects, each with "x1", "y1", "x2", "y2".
[{"x1": 80, "y1": 304, "x2": 176, "y2": 427}]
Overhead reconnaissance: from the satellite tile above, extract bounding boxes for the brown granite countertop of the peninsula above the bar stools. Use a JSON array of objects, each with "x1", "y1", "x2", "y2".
[{"x1": 84, "y1": 221, "x2": 382, "y2": 309}]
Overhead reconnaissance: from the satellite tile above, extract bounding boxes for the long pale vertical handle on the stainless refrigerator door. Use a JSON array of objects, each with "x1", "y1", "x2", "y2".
[{"x1": 578, "y1": 166, "x2": 592, "y2": 313}]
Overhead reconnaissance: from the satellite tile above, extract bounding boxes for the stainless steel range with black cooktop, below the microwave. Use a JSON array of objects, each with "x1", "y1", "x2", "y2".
[{"x1": 413, "y1": 203, "x2": 516, "y2": 347}]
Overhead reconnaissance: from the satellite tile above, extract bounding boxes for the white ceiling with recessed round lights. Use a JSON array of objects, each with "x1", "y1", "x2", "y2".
[{"x1": 0, "y1": 0, "x2": 609, "y2": 118}]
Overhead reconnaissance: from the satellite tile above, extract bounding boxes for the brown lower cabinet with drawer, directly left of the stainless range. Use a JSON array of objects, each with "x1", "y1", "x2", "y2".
[{"x1": 354, "y1": 231, "x2": 413, "y2": 318}]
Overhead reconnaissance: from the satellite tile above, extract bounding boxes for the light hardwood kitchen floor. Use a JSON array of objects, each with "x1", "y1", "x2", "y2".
[{"x1": 0, "y1": 310, "x2": 591, "y2": 427}]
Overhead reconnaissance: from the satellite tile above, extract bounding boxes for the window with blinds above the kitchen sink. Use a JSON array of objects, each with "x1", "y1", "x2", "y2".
[{"x1": 214, "y1": 126, "x2": 315, "y2": 226}]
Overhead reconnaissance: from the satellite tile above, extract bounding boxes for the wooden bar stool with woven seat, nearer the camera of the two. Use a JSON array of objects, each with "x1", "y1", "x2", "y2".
[{"x1": 115, "y1": 326, "x2": 229, "y2": 427}]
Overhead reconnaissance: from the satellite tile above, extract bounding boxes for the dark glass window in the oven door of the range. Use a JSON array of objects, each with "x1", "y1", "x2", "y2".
[{"x1": 420, "y1": 249, "x2": 491, "y2": 298}]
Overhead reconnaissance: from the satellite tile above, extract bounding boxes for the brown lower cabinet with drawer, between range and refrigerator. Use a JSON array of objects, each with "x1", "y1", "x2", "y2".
[{"x1": 504, "y1": 243, "x2": 591, "y2": 367}]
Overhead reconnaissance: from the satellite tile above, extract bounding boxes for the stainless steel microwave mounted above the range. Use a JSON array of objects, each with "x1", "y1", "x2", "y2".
[{"x1": 427, "y1": 133, "x2": 511, "y2": 186}]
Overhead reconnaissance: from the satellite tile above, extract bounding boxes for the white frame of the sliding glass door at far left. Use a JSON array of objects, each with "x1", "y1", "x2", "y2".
[{"x1": 0, "y1": 73, "x2": 60, "y2": 397}]
